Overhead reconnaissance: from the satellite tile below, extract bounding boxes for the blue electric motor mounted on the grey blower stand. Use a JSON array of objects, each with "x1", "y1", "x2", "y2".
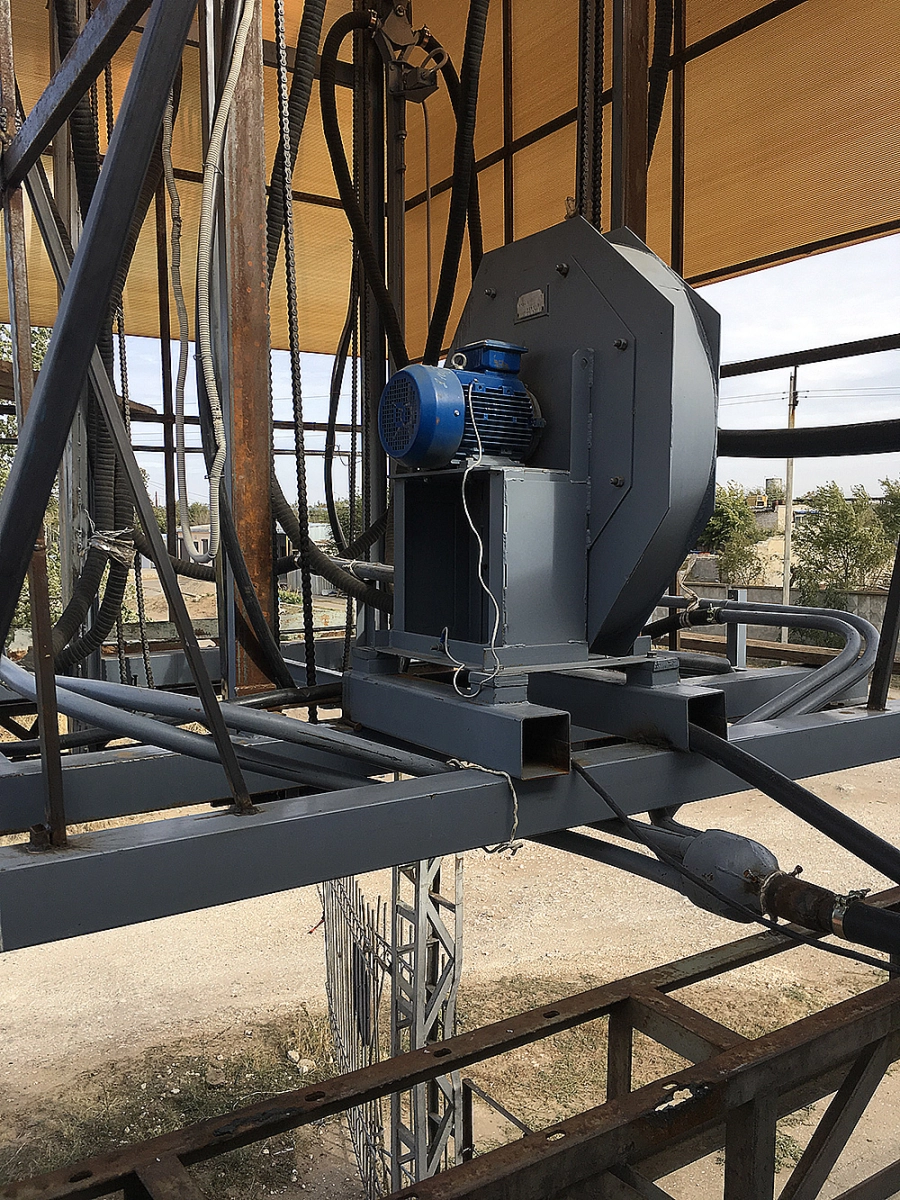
[{"x1": 378, "y1": 341, "x2": 545, "y2": 468}]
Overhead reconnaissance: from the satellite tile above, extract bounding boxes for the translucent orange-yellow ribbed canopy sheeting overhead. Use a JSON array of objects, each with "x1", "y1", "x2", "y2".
[{"x1": 7, "y1": 0, "x2": 900, "y2": 354}]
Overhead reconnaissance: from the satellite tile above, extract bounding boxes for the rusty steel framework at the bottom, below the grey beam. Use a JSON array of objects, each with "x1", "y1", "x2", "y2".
[{"x1": 0, "y1": 902, "x2": 900, "y2": 1200}]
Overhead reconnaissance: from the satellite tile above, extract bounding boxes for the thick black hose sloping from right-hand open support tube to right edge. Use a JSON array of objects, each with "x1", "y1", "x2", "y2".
[{"x1": 690, "y1": 724, "x2": 900, "y2": 883}]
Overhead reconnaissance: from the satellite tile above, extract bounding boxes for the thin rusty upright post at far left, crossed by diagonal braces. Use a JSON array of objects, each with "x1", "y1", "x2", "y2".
[{"x1": 0, "y1": 0, "x2": 66, "y2": 847}]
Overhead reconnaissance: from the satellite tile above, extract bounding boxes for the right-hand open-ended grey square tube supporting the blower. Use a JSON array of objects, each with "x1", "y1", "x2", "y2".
[{"x1": 528, "y1": 659, "x2": 727, "y2": 750}]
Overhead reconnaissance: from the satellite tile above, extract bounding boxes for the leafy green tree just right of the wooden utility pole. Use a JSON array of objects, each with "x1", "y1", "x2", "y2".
[{"x1": 793, "y1": 482, "x2": 893, "y2": 607}]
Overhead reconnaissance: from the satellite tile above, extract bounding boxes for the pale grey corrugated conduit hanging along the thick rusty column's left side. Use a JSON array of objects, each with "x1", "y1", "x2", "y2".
[{"x1": 190, "y1": 0, "x2": 256, "y2": 562}]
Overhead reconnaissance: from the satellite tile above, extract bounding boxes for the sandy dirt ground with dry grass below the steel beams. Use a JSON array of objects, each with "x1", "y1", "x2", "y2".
[{"x1": 0, "y1": 761, "x2": 900, "y2": 1200}]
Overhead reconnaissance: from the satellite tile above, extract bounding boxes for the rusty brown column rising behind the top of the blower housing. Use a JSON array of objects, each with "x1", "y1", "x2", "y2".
[{"x1": 610, "y1": 0, "x2": 649, "y2": 238}]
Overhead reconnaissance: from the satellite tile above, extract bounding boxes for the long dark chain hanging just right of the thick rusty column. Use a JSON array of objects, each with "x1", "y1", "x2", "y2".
[{"x1": 275, "y1": 0, "x2": 317, "y2": 724}]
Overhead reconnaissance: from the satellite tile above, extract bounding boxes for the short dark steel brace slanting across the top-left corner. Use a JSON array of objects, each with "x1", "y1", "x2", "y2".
[{"x1": 2, "y1": 0, "x2": 150, "y2": 188}]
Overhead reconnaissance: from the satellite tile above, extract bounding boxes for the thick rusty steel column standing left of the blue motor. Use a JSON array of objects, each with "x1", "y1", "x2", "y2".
[{"x1": 223, "y1": 6, "x2": 276, "y2": 695}]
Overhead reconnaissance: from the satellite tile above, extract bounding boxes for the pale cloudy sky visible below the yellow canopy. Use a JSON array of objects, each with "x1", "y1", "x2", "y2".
[{"x1": 126, "y1": 234, "x2": 900, "y2": 513}]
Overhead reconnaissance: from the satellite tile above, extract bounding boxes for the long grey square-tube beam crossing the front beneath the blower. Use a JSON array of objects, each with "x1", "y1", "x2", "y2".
[{"x1": 0, "y1": 702, "x2": 900, "y2": 949}]
